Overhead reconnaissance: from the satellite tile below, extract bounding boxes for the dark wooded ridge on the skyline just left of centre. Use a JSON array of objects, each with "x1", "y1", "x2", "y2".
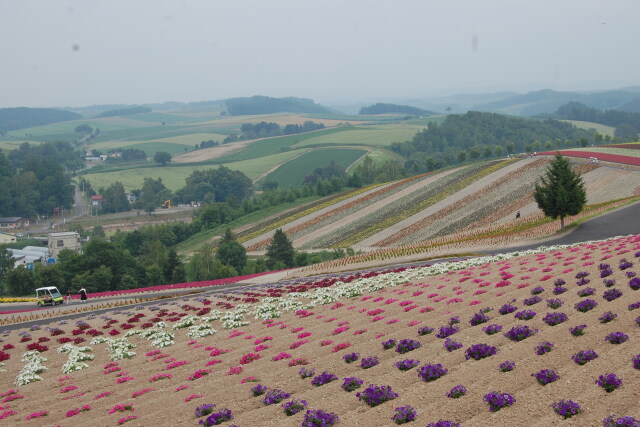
[{"x1": 226, "y1": 95, "x2": 332, "y2": 116}]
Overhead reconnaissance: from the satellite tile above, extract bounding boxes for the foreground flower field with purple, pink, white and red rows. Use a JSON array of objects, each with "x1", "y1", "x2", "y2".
[{"x1": 0, "y1": 236, "x2": 640, "y2": 426}]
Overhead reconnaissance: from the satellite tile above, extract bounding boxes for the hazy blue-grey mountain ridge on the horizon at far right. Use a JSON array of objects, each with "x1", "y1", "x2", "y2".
[{"x1": 473, "y1": 87, "x2": 640, "y2": 116}]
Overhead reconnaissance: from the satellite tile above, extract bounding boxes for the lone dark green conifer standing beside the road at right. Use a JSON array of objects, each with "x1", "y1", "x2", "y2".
[{"x1": 533, "y1": 153, "x2": 587, "y2": 229}]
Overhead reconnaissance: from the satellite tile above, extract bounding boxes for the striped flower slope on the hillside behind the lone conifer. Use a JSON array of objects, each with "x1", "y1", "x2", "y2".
[{"x1": 239, "y1": 157, "x2": 640, "y2": 255}]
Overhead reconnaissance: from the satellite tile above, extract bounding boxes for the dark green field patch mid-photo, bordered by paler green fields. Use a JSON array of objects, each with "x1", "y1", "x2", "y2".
[{"x1": 265, "y1": 148, "x2": 367, "y2": 188}]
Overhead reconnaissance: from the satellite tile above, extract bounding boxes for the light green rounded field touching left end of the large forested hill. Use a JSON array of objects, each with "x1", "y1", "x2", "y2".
[{"x1": 295, "y1": 124, "x2": 424, "y2": 147}]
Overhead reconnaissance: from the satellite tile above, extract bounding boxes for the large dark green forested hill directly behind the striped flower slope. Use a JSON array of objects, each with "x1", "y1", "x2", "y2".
[{"x1": 391, "y1": 111, "x2": 595, "y2": 170}]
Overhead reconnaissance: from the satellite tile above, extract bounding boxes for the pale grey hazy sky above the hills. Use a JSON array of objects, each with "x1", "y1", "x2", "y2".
[{"x1": 0, "y1": 0, "x2": 640, "y2": 107}]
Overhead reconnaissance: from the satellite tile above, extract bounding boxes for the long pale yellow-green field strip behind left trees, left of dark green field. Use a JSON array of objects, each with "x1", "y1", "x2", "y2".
[{"x1": 83, "y1": 151, "x2": 300, "y2": 191}]
